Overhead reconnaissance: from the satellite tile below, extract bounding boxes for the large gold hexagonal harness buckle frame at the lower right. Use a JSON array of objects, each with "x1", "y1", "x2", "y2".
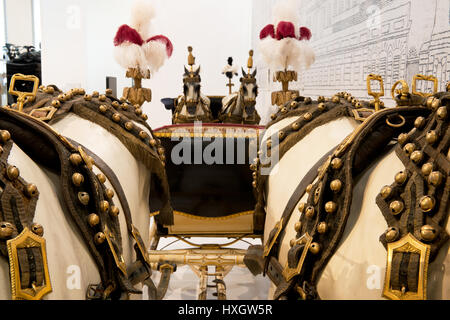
[{"x1": 383, "y1": 233, "x2": 431, "y2": 300}]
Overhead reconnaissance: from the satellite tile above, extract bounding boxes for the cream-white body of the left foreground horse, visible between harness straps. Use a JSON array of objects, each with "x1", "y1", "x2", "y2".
[{"x1": 0, "y1": 86, "x2": 162, "y2": 300}]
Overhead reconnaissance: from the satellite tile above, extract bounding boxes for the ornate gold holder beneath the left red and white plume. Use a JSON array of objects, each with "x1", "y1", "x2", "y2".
[{"x1": 122, "y1": 68, "x2": 152, "y2": 106}]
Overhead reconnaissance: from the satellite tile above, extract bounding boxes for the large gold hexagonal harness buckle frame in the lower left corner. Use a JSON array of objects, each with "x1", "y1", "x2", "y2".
[{"x1": 6, "y1": 228, "x2": 52, "y2": 300}]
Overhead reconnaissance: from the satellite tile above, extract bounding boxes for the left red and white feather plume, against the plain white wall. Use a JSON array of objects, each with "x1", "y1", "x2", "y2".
[{"x1": 114, "y1": 0, "x2": 173, "y2": 73}]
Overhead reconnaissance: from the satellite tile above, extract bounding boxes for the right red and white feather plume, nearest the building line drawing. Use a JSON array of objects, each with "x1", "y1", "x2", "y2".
[{"x1": 259, "y1": 1, "x2": 316, "y2": 71}]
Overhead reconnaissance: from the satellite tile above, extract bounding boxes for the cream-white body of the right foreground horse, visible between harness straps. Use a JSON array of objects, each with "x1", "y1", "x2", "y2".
[{"x1": 262, "y1": 92, "x2": 450, "y2": 299}]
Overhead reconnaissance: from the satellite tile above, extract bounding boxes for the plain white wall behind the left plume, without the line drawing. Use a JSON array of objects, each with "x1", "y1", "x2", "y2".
[{"x1": 41, "y1": 0, "x2": 252, "y2": 128}]
